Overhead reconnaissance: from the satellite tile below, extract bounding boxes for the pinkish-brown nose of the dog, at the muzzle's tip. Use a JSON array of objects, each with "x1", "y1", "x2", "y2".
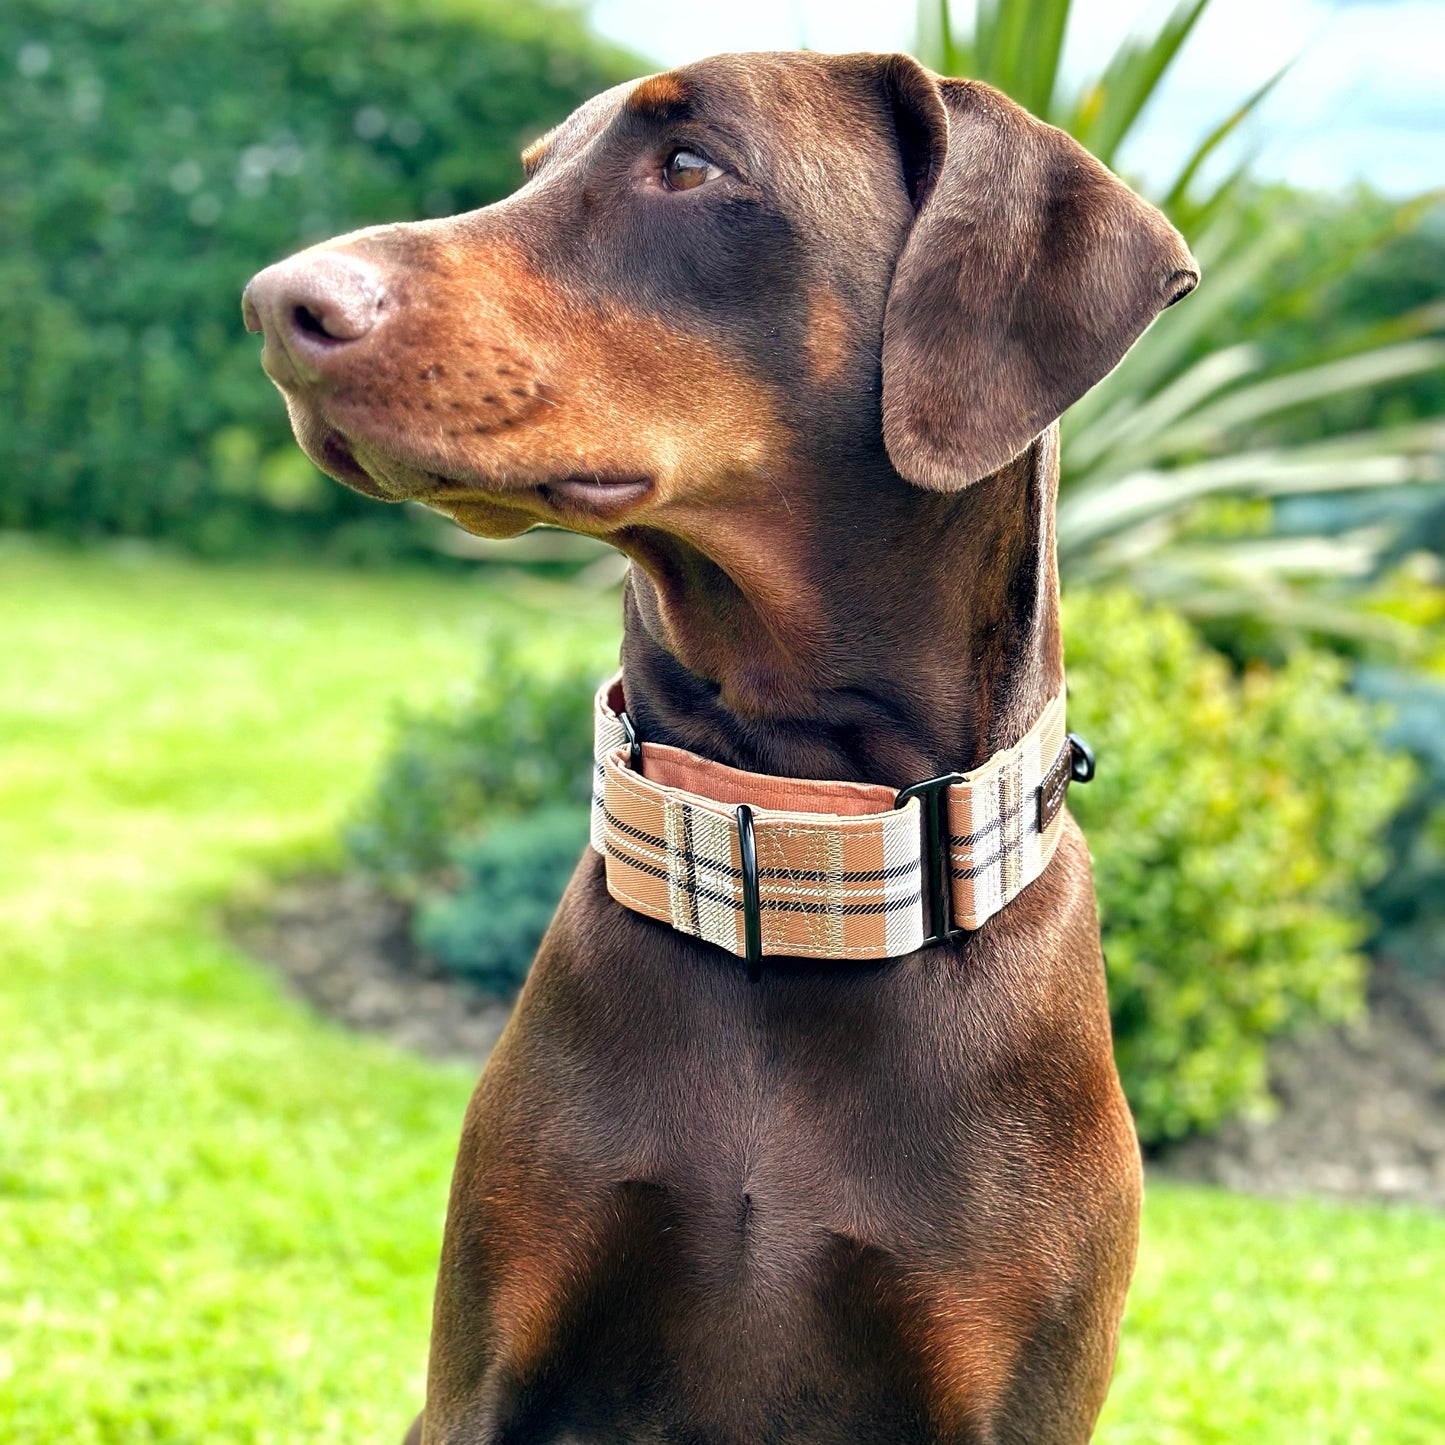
[{"x1": 241, "y1": 251, "x2": 386, "y2": 380}]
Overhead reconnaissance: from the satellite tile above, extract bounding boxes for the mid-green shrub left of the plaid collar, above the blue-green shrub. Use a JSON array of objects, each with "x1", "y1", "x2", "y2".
[{"x1": 345, "y1": 642, "x2": 598, "y2": 884}]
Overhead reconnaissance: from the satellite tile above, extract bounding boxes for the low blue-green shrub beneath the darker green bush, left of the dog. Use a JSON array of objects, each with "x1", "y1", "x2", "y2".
[{"x1": 413, "y1": 806, "x2": 587, "y2": 996}]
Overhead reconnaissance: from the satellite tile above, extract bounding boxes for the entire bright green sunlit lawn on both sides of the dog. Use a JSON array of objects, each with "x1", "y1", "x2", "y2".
[{"x1": 0, "y1": 545, "x2": 1445, "y2": 1445}]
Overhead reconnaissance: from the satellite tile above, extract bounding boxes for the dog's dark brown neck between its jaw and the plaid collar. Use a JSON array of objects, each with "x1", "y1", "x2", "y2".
[{"x1": 618, "y1": 429, "x2": 1064, "y2": 785}]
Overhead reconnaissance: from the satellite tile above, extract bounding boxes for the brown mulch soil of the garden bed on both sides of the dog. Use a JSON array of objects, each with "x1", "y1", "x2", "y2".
[{"x1": 234, "y1": 877, "x2": 1445, "y2": 1208}]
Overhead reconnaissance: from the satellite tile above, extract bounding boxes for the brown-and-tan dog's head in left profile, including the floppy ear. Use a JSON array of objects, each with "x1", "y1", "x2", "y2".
[{"x1": 244, "y1": 53, "x2": 1198, "y2": 536}]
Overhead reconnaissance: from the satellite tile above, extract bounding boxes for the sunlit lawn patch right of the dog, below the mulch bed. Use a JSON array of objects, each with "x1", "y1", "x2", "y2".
[{"x1": 1100, "y1": 1186, "x2": 1445, "y2": 1445}]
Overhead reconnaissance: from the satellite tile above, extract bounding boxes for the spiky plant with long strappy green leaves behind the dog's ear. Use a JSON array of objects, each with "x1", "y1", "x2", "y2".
[{"x1": 918, "y1": 0, "x2": 1445, "y2": 640}]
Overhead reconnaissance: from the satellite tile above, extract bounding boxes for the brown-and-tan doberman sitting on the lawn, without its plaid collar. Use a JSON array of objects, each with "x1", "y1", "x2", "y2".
[{"x1": 244, "y1": 53, "x2": 1198, "y2": 1445}]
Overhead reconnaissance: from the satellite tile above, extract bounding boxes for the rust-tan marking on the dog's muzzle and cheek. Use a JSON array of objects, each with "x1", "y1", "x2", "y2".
[{"x1": 323, "y1": 231, "x2": 790, "y2": 526}]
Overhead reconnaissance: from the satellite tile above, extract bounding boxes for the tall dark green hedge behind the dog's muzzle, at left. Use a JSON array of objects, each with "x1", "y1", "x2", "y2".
[{"x1": 0, "y1": 0, "x2": 636, "y2": 558}]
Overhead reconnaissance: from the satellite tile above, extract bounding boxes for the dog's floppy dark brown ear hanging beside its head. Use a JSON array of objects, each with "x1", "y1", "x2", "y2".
[{"x1": 883, "y1": 56, "x2": 1199, "y2": 490}]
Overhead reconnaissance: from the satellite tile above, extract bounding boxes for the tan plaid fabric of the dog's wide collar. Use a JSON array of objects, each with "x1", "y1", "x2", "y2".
[{"x1": 592, "y1": 676, "x2": 1066, "y2": 959}]
